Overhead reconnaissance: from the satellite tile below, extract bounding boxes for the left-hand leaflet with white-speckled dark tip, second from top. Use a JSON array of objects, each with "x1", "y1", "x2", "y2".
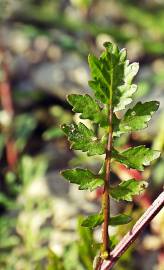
[{"x1": 62, "y1": 123, "x2": 105, "y2": 156}]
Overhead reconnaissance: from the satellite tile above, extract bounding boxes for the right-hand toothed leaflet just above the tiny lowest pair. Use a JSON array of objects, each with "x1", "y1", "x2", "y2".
[{"x1": 110, "y1": 179, "x2": 148, "y2": 202}]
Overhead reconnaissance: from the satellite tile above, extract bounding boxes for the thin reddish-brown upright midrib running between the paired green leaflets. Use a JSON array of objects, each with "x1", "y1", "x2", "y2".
[{"x1": 102, "y1": 98, "x2": 113, "y2": 258}]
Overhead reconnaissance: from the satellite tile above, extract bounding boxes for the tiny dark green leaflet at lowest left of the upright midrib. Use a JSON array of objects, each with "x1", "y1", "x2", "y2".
[{"x1": 81, "y1": 214, "x2": 104, "y2": 228}]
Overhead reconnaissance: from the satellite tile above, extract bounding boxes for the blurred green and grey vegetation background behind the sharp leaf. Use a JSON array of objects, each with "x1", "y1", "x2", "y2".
[{"x1": 0, "y1": 0, "x2": 164, "y2": 270}]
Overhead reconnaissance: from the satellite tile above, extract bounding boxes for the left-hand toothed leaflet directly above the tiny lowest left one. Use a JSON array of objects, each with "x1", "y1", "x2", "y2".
[{"x1": 61, "y1": 168, "x2": 104, "y2": 191}]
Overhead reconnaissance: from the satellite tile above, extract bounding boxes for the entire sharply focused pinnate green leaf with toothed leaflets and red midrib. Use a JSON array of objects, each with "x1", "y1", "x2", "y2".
[{"x1": 61, "y1": 42, "x2": 160, "y2": 266}]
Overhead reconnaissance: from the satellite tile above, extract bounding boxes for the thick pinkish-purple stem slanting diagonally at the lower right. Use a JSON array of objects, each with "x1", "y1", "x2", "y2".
[{"x1": 99, "y1": 191, "x2": 164, "y2": 270}]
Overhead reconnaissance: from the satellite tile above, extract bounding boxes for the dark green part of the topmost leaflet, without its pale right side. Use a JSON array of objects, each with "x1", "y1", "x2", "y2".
[{"x1": 88, "y1": 43, "x2": 124, "y2": 104}]
